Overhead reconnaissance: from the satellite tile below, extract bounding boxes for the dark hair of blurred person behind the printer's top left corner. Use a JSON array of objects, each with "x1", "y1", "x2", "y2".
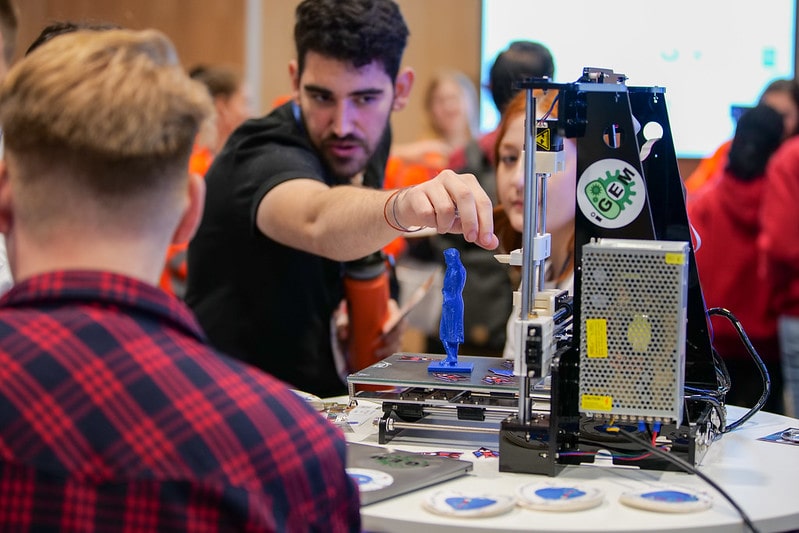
[{"x1": 489, "y1": 41, "x2": 555, "y2": 113}]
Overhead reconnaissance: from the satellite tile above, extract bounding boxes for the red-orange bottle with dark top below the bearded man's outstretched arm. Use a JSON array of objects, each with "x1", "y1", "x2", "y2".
[{"x1": 344, "y1": 252, "x2": 390, "y2": 372}]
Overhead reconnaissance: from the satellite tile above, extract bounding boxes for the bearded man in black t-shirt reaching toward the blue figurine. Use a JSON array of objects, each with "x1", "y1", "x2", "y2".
[{"x1": 186, "y1": 0, "x2": 498, "y2": 396}]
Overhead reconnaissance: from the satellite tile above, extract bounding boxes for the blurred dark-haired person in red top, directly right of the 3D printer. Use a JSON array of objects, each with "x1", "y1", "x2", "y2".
[{"x1": 687, "y1": 104, "x2": 787, "y2": 413}]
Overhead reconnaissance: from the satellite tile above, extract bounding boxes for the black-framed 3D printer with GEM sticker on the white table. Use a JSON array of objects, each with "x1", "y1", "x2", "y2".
[{"x1": 348, "y1": 68, "x2": 748, "y2": 475}]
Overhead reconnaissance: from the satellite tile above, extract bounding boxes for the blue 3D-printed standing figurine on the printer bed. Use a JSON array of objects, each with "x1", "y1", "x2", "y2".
[{"x1": 427, "y1": 248, "x2": 474, "y2": 372}]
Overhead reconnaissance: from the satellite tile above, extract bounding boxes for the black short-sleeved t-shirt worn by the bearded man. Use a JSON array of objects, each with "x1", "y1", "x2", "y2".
[{"x1": 186, "y1": 103, "x2": 391, "y2": 397}]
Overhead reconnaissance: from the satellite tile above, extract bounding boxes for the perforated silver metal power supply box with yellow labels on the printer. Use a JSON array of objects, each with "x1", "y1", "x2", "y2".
[{"x1": 579, "y1": 239, "x2": 689, "y2": 424}]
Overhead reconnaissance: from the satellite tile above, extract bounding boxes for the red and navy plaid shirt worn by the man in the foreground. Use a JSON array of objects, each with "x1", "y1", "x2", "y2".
[{"x1": 0, "y1": 271, "x2": 360, "y2": 532}]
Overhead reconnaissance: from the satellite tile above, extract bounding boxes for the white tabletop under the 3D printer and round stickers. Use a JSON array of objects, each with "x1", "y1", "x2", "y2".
[{"x1": 342, "y1": 400, "x2": 799, "y2": 533}]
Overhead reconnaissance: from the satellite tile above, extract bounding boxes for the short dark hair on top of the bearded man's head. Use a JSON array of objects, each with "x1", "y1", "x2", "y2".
[{"x1": 294, "y1": 0, "x2": 408, "y2": 81}]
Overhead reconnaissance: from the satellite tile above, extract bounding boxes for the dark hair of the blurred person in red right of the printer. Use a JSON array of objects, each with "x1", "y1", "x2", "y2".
[{"x1": 725, "y1": 104, "x2": 783, "y2": 181}]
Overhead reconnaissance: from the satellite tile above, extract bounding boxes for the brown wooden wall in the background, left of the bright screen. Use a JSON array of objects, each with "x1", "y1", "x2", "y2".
[{"x1": 18, "y1": 0, "x2": 481, "y2": 141}]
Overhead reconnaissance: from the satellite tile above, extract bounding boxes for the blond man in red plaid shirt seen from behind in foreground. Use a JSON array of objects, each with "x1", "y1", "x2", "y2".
[{"x1": 0, "y1": 30, "x2": 360, "y2": 531}]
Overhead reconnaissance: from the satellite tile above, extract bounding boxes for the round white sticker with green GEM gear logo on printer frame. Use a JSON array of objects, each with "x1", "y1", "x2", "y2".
[{"x1": 577, "y1": 159, "x2": 646, "y2": 229}]
